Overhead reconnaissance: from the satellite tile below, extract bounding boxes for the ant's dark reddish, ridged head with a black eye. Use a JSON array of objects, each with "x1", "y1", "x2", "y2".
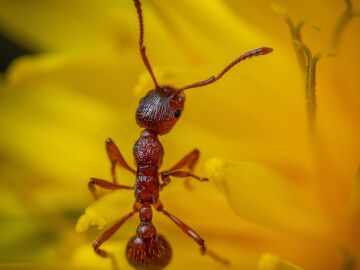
[{"x1": 136, "y1": 86, "x2": 185, "y2": 134}]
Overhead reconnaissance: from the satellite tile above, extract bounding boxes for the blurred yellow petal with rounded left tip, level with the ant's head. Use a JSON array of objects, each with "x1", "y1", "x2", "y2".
[{"x1": 6, "y1": 50, "x2": 143, "y2": 108}]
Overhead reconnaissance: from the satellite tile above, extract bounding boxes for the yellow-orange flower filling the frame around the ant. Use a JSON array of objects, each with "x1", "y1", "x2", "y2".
[{"x1": 0, "y1": 0, "x2": 360, "y2": 270}]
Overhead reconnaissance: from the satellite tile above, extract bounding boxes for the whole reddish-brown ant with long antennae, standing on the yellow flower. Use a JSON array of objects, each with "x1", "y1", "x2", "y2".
[{"x1": 89, "y1": 0, "x2": 272, "y2": 269}]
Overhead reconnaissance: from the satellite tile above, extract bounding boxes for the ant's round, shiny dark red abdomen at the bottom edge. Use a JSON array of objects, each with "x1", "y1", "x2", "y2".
[{"x1": 126, "y1": 234, "x2": 172, "y2": 270}]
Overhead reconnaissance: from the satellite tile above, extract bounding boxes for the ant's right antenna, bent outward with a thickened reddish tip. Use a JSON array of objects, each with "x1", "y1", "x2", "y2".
[{"x1": 178, "y1": 47, "x2": 273, "y2": 92}]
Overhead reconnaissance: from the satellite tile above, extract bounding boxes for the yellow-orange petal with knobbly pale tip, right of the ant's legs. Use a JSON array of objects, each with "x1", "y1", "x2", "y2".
[{"x1": 205, "y1": 158, "x2": 329, "y2": 236}]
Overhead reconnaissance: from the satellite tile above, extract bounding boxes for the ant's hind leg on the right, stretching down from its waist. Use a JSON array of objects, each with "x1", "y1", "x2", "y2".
[{"x1": 155, "y1": 201, "x2": 230, "y2": 265}]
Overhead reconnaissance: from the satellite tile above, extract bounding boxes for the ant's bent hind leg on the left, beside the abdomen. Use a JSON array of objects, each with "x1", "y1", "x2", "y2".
[{"x1": 92, "y1": 209, "x2": 138, "y2": 270}]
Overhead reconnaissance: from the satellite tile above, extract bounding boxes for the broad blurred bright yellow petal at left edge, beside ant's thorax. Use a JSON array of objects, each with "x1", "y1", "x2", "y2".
[{"x1": 0, "y1": 85, "x2": 134, "y2": 192}]
